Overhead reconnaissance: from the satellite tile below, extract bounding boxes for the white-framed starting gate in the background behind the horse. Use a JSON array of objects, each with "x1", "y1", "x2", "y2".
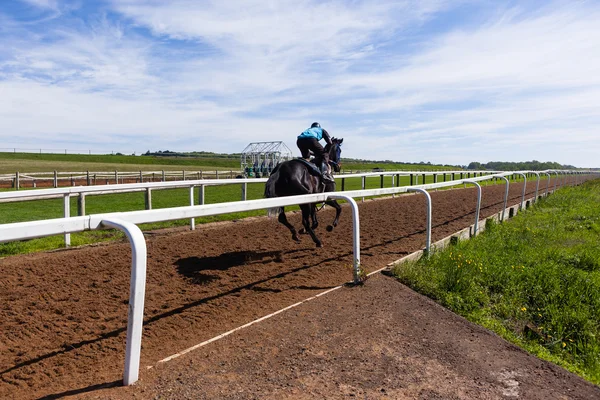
[{"x1": 240, "y1": 142, "x2": 292, "y2": 178}]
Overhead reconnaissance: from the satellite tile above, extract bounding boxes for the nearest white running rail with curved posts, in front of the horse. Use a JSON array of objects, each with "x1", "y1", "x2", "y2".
[{"x1": 0, "y1": 172, "x2": 599, "y2": 385}]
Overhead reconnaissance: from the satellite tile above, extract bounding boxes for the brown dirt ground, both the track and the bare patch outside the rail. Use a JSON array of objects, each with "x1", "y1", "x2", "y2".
[{"x1": 0, "y1": 180, "x2": 600, "y2": 399}]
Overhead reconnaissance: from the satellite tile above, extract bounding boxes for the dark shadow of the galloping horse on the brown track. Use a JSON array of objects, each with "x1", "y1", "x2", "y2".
[{"x1": 175, "y1": 251, "x2": 283, "y2": 285}]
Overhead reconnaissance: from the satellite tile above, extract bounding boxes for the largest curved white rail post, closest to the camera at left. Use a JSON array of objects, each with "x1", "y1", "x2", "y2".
[{"x1": 102, "y1": 219, "x2": 147, "y2": 386}]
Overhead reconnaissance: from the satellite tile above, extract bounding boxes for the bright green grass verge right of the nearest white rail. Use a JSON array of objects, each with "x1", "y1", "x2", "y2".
[{"x1": 394, "y1": 180, "x2": 600, "y2": 384}]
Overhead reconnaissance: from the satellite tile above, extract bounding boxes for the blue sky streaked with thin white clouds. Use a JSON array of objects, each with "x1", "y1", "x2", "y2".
[{"x1": 0, "y1": 0, "x2": 600, "y2": 167}]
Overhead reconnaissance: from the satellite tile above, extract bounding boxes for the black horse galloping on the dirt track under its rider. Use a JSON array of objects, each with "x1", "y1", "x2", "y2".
[{"x1": 265, "y1": 138, "x2": 344, "y2": 247}]
